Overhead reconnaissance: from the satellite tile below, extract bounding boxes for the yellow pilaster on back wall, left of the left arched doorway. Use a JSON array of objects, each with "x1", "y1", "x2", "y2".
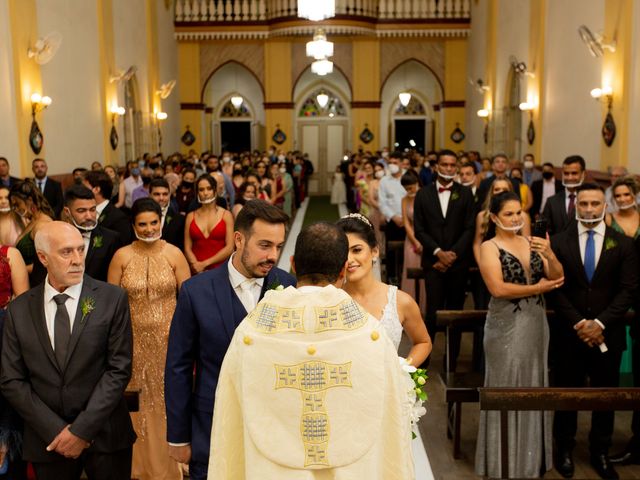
[{"x1": 178, "y1": 42, "x2": 206, "y2": 153}]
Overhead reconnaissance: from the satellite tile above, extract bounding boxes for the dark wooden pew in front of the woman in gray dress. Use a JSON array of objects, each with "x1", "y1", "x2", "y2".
[{"x1": 480, "y1": 388, "x2": 640, "y2": 478}]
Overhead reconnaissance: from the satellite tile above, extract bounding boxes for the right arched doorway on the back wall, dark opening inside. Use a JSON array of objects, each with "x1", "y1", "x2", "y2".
[{"x1": 380, "y1": 60, "x2": 444, "y2": 151}]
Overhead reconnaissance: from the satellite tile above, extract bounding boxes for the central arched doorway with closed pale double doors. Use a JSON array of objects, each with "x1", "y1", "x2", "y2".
[{"x1": 294, "y1": 69, "x2": 351, "y2": 195}]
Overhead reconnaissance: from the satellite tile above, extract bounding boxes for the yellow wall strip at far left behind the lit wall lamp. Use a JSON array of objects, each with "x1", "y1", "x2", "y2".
[{"x1": 8, "y1": 0, "x2": 41, "y2": 176}]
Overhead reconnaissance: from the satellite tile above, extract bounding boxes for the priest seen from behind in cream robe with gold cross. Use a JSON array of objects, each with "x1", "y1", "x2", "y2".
[{"x1": 208, "y1": 223, "x2": 414, "y2": 480}]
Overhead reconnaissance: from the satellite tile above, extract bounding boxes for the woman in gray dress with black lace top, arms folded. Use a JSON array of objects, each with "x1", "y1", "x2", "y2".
[{"x1": 476, "y1": 192, "x2": 564, "y2": 478}]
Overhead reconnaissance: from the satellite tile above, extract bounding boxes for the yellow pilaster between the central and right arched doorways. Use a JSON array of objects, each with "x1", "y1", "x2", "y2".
[{"x1": 351, "y1": 38, "x2": 380, "y2": 150}]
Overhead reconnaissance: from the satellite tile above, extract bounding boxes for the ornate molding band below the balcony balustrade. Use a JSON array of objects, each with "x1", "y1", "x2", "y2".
[{"x1": 174, "y1": 25, "x2": 470, "y2": 41}]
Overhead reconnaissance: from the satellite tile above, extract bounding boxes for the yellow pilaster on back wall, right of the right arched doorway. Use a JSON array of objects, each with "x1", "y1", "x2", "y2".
[{"x1": 441, "y1": 39, "x2": 468, "y2": 150}]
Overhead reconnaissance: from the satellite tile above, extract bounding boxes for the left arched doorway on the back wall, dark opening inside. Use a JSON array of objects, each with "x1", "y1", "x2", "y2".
[{"x1": 202, "y1": 61, "x2": 265, "y2": 153}]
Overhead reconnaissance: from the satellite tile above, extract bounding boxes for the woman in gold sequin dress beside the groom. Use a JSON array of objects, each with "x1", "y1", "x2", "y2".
[{"x1": 108, "y1": 198, "x2": 190, "y2": 480}]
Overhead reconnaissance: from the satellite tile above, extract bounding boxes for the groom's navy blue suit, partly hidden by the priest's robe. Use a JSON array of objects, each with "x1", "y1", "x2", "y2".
[{"x1": 164, "y1": 262, "x2": 296, "y2": 480}]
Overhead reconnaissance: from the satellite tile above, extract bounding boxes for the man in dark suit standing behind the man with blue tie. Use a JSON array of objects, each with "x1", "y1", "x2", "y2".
[{"x1": 542, "y1": 155, "x2": 586, "y2": 235}]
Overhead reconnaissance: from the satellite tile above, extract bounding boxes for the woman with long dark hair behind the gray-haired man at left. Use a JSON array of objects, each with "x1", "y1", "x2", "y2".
[{"x1": 9, "y1": 180, "x2": 54, "y2": 285}]
